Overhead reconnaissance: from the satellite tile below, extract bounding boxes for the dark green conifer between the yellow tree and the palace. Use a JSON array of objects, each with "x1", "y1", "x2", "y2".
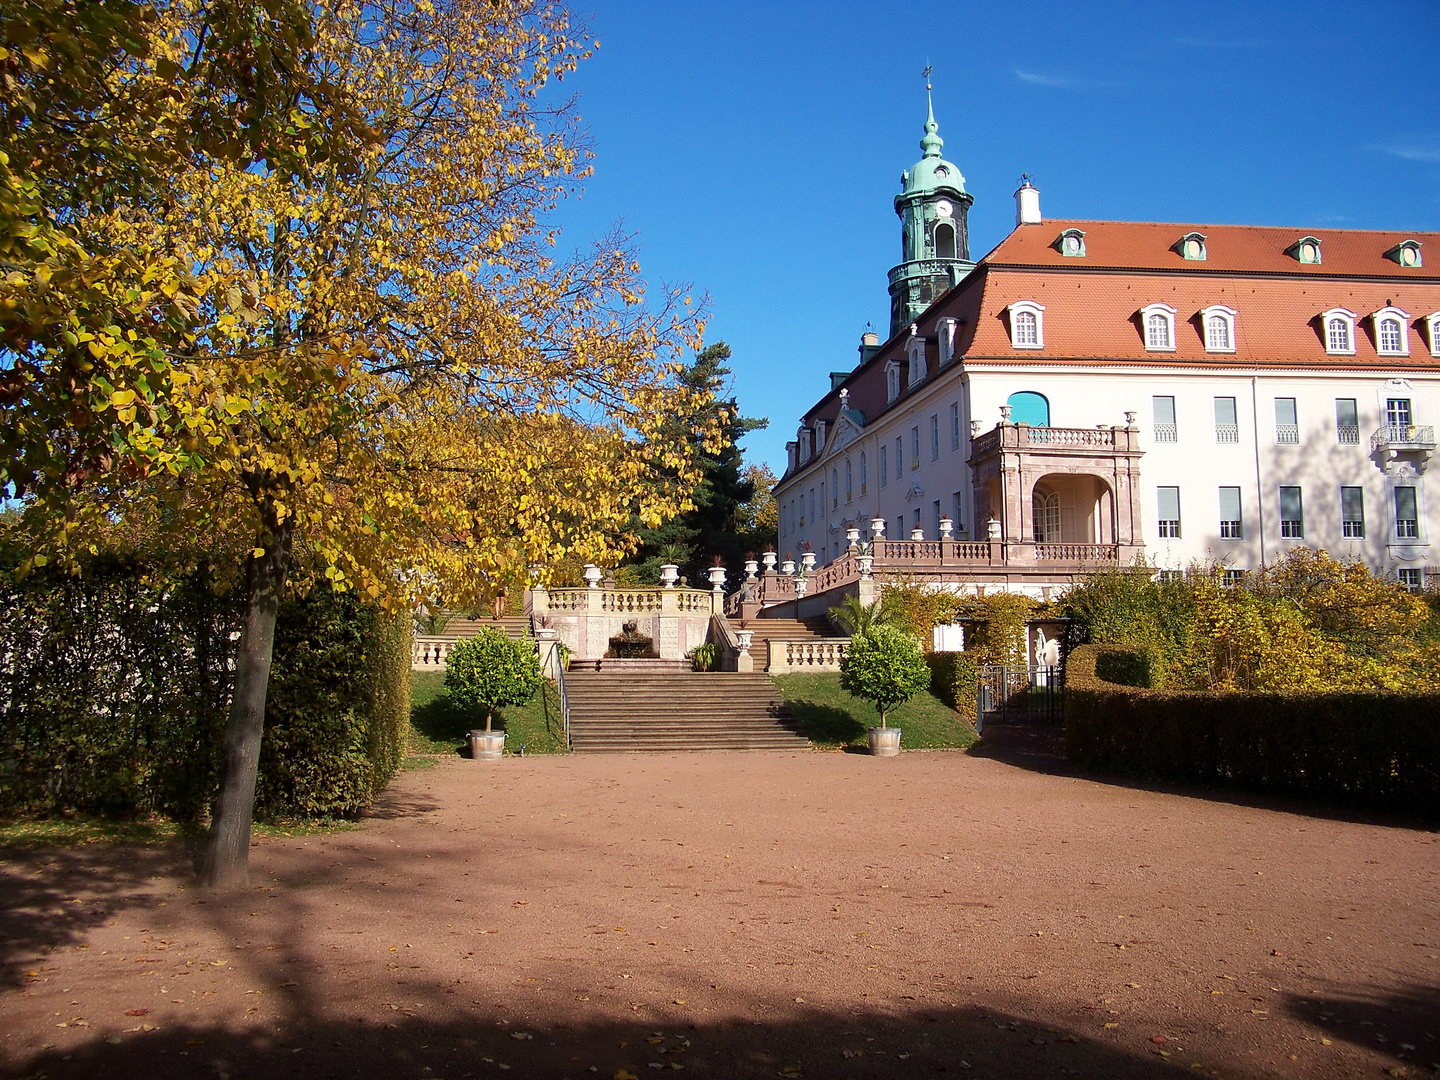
[{"x1": 632, "y1": 341, "x2": 775, "y2": 585}]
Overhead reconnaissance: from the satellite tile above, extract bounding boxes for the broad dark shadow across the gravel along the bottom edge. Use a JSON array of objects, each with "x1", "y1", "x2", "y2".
[{"x1": 8, "y1": 994, "x2": 1215, "y2": 1080}]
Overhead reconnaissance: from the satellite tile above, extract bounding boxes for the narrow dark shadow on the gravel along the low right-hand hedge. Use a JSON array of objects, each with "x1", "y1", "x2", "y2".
[{"x1": 966, "y1": 720, "x2": 1437, "y2": 832}]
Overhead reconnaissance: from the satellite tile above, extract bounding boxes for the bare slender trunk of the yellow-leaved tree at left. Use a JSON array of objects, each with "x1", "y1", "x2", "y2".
[{"x1": 200, "y1": 507, "x2": 291, "y2": 888}]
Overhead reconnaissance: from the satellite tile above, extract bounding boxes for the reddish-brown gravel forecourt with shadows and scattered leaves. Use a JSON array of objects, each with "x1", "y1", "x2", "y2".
[{"x1": 0, "y1": 732, "x2": 1440, "y2": 1080}]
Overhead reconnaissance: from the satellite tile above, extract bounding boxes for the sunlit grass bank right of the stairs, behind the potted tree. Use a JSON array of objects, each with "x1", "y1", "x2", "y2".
[{"x1": 775, "y1": 671, "x2": 979, "y2": 750}]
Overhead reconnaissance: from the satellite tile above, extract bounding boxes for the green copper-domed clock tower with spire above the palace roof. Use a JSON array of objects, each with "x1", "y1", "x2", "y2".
[{"x1": 890, "y1": 83, "x2": 975, "y2": 337}]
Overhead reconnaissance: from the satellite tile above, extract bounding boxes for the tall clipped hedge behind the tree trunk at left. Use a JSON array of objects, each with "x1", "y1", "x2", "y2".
[{"x1": 0, "y1": 557, "x2": 410, "y2": 821}]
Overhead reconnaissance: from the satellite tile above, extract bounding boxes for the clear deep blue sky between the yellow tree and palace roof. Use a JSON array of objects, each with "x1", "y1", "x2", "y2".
[{"x1": 541, "y1": 0, "x2": 1440, "y2": 472}]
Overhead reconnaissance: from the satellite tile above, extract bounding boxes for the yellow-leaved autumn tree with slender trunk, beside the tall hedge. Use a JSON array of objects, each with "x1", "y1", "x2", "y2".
[{"x1": 7, "y1": 0, "x2": 721, "y2": 887}]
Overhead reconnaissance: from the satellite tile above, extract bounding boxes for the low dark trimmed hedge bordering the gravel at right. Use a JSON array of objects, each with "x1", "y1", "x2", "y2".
[{"x1": 1066, "y1": 645, "x2": 1440, "y2": 816}]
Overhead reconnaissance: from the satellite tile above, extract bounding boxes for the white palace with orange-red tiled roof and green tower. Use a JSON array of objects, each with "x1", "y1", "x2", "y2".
[{"x1": 775, "y1": 97, "x2": 1440, "y2": 590}]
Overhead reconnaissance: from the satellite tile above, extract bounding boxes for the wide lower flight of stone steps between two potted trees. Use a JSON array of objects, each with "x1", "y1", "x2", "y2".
[{"x1": 564, "y1": 670, "x2": 809, "y2": 753}]
